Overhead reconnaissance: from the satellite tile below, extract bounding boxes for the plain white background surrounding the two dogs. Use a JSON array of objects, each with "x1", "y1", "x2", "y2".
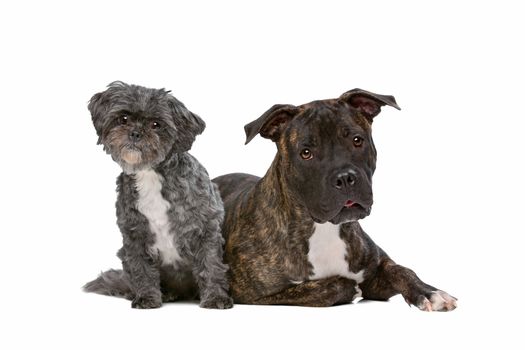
[{"x1": 0, "y1": 0, "x2": 525, "y2": 349}]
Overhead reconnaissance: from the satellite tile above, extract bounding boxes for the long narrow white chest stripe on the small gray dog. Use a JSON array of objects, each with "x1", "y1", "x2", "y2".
[{"x1": 135, "y1": 170, "x2": 181, "y2": 265}]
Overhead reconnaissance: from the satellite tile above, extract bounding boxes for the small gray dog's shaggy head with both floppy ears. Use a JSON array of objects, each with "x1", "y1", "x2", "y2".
[{"x1": 88, "y1": 81, "x2": 206, "y2": 173}]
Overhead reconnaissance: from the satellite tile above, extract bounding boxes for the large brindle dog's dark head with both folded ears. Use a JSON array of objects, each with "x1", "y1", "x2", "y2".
[{"x1": 244, "y1": 89, "x2": 400, "y2": 224}]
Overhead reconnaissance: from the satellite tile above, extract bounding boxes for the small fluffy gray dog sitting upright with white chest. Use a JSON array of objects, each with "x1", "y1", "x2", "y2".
[{"x1": 84, "y1": 81, "x2": 233, "y2": 309}]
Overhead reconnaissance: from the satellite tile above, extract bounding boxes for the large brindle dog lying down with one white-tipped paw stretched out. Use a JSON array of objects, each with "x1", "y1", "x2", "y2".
[{"x1": 214, "y1": 89, "x2": 456, "y2": 311}]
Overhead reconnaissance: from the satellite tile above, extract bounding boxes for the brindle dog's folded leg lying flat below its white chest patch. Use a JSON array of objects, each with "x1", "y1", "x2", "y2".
[{"x1": 250, "y1": 276, "x2": 360, "y2": 307}]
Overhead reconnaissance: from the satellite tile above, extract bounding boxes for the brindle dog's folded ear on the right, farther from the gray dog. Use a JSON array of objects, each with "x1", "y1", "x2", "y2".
[{"x1": 339, "y1": 89, "x2": 401, "y2": 122}]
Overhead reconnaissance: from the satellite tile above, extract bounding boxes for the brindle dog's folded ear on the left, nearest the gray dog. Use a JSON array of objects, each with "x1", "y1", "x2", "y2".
[{"x1": 244, "y1": 105, "x2": 299, "y2": 145}]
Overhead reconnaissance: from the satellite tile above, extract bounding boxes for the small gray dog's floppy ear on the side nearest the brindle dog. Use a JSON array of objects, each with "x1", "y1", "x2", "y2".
[{"x1": 168, "y1": 94, "x2": 206, "y2": 152}]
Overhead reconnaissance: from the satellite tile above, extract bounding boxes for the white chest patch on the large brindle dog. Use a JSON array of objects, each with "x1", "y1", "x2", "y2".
[{"x1": 308, "y1": 222, "x2": 364, "y2": 284}]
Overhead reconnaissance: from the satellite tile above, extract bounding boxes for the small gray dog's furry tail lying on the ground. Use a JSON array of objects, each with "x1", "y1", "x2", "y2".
[{"x1": 83, "y1": 270, "x2": 134, "y2": 300}]
